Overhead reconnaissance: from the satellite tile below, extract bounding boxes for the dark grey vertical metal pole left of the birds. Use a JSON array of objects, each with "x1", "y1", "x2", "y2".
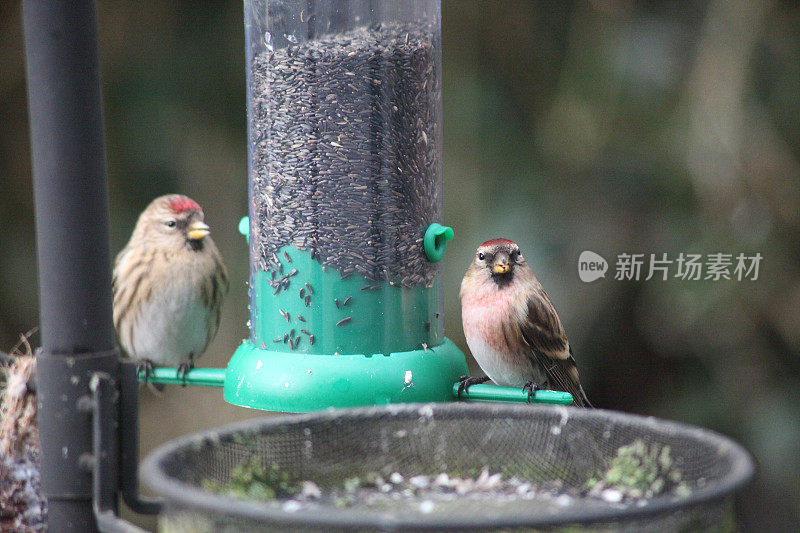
[{"x1": 23, "y1": 0, "x2": 118, "y2": 532}]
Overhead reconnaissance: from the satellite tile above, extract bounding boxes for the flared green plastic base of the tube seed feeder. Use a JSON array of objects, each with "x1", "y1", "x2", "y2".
[{"x1": 224, "y1": 338, "x2": 468, "y2": 413}]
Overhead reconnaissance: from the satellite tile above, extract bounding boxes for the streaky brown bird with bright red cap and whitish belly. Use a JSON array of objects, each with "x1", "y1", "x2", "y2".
[{"x1": 112, "y1": 194, "x2": 229, "y2": 384}]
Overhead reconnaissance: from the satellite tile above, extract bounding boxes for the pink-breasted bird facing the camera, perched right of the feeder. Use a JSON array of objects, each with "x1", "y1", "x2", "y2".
[{"x1": 459, "y1": 238, "x2": 592, "y2": 407}]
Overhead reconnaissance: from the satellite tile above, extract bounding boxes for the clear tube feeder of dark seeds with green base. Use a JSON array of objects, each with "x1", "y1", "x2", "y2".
[{"x1": 225, "y1": 0, "x2": 467, "y2": 411}]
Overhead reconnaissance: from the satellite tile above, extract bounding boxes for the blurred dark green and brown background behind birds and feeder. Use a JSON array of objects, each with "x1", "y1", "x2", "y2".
[{"x1": 0, "y1": 0, "x2": 800, "y2": 531}]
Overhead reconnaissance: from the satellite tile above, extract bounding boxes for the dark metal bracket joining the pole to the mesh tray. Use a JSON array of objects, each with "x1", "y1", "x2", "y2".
[{"x1": 87, "y1": 362, "x2": 162, "y2": 533}]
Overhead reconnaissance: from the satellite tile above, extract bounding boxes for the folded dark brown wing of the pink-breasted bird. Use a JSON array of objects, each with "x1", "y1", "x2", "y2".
[{"x1": 521, "y1": 286, "x2": 589, "y2": 407}]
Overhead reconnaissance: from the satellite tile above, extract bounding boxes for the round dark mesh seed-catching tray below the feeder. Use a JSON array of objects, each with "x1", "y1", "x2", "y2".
[{"x1": 144, "y1": 404, "x2": 753, "y2": 531}]
